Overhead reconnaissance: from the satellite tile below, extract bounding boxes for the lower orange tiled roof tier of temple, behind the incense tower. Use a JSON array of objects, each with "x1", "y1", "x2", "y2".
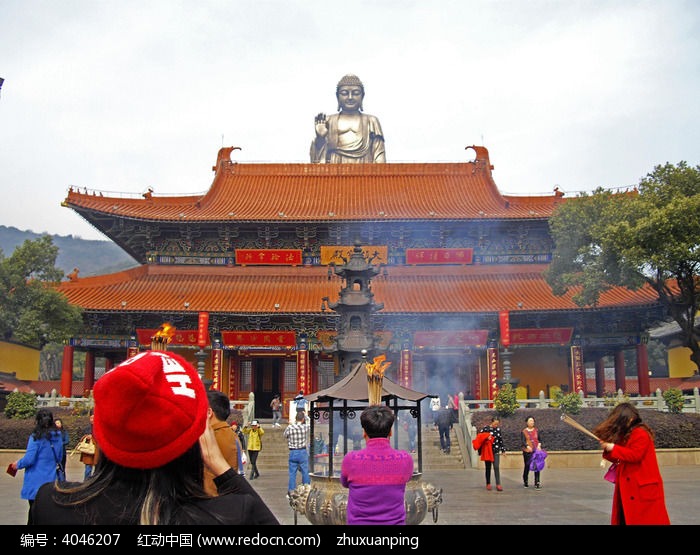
[{"x1": 59, "y1": 264, "x2": 656, "y2": 314}]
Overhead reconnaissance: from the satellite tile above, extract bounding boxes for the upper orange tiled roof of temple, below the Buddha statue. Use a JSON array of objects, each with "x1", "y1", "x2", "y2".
[{"x1": 63, "y1": 154, "x2": 562, "y2": 222}]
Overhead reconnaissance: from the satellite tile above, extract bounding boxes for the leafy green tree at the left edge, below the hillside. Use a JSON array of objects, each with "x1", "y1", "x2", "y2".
[{"x1": 0, "y1": 235, "x2": 83, "y2": 348}]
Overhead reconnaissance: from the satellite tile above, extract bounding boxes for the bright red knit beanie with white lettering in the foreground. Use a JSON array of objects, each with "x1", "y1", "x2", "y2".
[{"x1": 93, "y1": 351, "x2": 209, "y2": 468}]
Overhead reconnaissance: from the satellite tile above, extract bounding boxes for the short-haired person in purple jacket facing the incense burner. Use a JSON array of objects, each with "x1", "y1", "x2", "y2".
[{"x1": 340, "y1": 405, "x2": 413, "y2": 525}]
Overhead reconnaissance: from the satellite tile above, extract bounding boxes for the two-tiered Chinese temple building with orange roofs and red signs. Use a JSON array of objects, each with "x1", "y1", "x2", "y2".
[{"x1": 60, "y1": 146, "x2": 663, "y2": 416}]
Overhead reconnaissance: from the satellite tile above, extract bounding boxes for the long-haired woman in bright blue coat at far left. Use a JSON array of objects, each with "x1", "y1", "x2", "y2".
[{"x1": 11, "y1": 408, "x2": 63, "y2": 520}]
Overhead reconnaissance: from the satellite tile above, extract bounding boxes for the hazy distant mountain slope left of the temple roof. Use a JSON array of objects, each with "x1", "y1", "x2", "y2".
[{"x1": 0, "y1": 225, "x2": 139, "y2": 277}]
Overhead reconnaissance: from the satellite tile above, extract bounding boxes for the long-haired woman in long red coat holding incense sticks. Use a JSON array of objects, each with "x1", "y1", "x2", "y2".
[{"x1": 593, "y1": 403, "x2": 671, "y2": 524}]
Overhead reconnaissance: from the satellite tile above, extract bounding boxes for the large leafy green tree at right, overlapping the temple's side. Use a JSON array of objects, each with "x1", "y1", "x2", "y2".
[{"x1": 545, "y1": 162, "x2": 700, "y2": 374}]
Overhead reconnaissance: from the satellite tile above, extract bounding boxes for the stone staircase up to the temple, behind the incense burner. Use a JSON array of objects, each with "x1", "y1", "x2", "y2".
[{"x1": 252, "y1": 418, "x2": 465, "y2": 474}]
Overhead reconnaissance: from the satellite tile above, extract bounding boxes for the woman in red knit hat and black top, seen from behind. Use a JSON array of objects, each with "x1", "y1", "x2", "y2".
[{"x1": 29, "y1": 351, "x2": 279, "y2": 525}]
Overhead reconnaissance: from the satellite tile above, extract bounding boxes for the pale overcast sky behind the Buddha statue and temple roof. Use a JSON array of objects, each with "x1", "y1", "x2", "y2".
[{"x1": 0, "y1": 0, "x2": 700, "y2": 242}]
